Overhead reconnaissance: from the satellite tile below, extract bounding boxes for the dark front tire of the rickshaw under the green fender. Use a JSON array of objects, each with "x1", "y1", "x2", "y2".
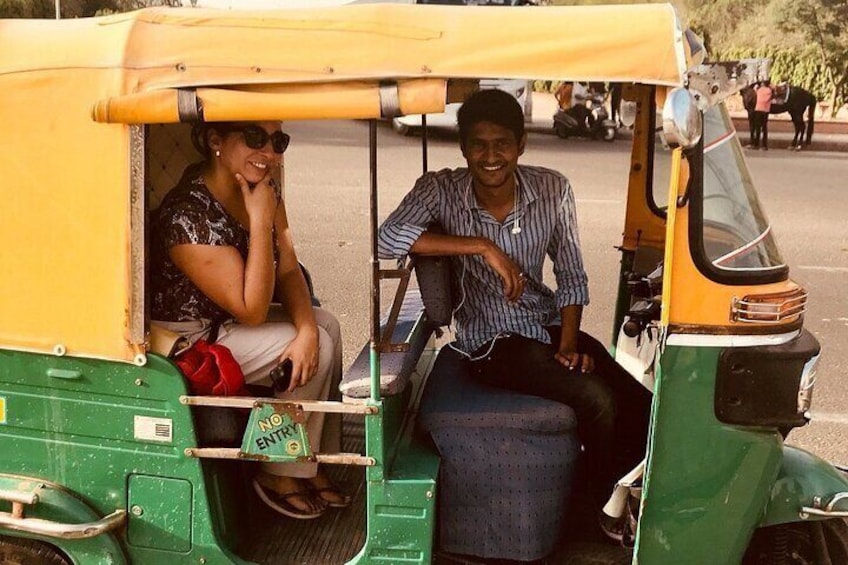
[{"x1": 742, "y1": 518, "x2": 848, "y2": 565}]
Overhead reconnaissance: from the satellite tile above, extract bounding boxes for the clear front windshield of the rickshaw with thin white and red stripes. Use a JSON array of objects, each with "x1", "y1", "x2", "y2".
[{"x1": 691, "y1": 105, "x2": 787, "y2": 284}]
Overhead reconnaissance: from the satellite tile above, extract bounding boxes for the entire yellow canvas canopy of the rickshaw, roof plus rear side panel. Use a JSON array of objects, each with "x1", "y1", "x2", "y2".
[{"x1": 0, "y1": 4, "x2": 686, "y2": 363}]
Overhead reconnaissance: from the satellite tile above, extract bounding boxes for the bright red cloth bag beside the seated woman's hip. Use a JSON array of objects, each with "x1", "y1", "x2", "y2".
[{"x1": 174, "y1": 339, "x2": 250, "y2": 396}]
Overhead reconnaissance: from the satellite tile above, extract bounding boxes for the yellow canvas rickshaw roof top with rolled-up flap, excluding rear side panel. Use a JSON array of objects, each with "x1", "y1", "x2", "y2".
[{"x1": 0, "y1": 4, "x2": 686, "y2": 122}]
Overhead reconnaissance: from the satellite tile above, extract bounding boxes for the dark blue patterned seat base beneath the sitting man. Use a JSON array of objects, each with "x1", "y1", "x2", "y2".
[{"x1": 418, "y1": 347, "x2": 580, "y2": 561}]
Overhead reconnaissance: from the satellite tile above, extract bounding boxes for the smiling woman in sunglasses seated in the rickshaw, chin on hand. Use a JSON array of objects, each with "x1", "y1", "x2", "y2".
[{"x1": 151, "y1": 121, "x2": 348, "y2": 519}]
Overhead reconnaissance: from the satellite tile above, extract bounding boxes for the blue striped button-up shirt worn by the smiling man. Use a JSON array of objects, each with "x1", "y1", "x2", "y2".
[{"x1": 378, "y1": 165, "x2": 589, "y2": 353}]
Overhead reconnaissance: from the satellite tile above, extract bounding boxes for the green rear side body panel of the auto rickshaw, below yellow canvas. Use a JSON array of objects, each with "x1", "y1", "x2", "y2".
[{"x1": 0, "y1": 351, "x2": 250, "y2": 563}]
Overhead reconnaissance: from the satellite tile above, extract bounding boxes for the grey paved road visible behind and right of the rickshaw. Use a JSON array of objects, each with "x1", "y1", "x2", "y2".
[{"x1": 286, "y1": 121, "x2": 848, "y2": 463}]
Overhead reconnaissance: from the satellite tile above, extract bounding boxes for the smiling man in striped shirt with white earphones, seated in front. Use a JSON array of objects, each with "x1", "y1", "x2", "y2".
[{"x1": 379, "y1": 90, "x2": 650, "y2": 532}]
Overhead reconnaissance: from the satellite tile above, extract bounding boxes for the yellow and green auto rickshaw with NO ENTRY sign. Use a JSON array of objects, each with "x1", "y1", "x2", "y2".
[{"x1": 0, "y1": 4, "x2": 848, "y2": 565}]
